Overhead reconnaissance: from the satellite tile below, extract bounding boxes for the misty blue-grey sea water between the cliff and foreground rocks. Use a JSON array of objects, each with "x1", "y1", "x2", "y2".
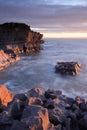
[{"x1": 0, "y1": 39, "x2": 87, "y2": 99}]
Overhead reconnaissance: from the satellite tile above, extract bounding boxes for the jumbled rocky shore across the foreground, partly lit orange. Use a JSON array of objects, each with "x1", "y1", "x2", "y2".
[{"x1": 0, "y1": 85, "x2": 87, "y2": 130}]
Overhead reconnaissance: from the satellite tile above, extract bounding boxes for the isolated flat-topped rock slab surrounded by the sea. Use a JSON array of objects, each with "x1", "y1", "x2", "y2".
[{"x1": 55, "y1": 62, "x2": 81, "y2": 75}]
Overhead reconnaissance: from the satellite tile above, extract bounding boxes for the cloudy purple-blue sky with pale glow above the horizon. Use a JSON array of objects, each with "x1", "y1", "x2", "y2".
[{"x1": 0, "y1": 0, "x2": 87, "y2": 38}]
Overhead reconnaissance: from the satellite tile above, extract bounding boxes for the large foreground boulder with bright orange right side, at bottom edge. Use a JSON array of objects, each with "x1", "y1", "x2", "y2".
[{"x1": 21, "y1": 105, "x2": 49, "y2": 130}]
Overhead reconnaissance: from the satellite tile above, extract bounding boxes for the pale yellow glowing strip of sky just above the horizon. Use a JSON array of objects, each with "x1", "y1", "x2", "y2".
[{"x1": 44, "y1": 32, "x2": 87, "y2": 38}]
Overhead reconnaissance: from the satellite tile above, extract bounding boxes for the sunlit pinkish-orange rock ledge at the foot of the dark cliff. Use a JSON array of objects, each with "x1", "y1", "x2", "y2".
[{"x1": 0, "y1": 50, "x2": 20, "y2": 70}]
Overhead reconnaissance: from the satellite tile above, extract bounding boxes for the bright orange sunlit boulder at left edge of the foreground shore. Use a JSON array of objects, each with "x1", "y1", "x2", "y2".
[{"x1": 0, "y1": 85, "x2": 14, "y2": 106}]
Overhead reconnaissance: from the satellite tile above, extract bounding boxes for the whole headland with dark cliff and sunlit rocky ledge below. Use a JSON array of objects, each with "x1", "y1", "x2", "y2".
[{"x1": 0, "y1": 23, "x2": 44, "y2": 70}]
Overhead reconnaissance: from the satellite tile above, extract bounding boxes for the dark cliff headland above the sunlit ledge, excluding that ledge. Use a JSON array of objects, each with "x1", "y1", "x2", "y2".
[{"x1": 0, "y1": 23, "x2": 43, "y2": 53}]
